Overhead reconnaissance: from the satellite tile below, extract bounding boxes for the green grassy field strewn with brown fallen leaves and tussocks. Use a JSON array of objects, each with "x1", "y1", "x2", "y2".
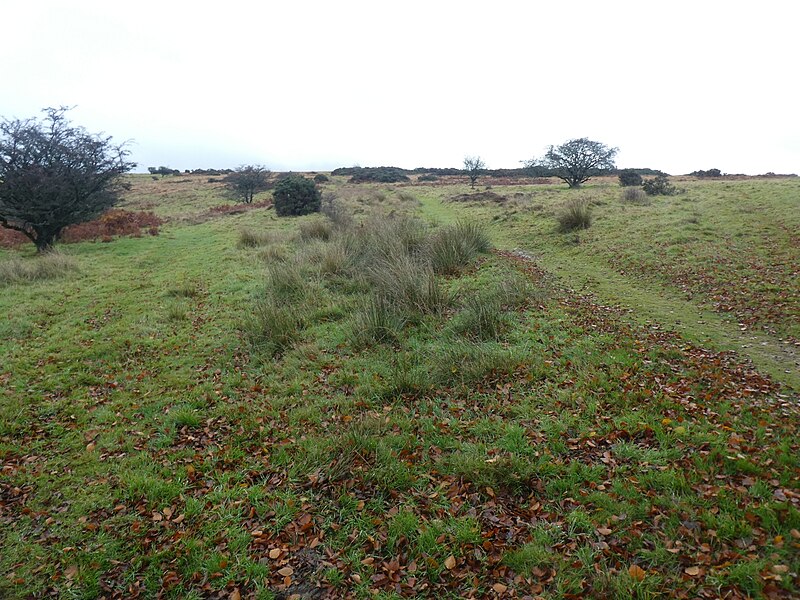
[{"x1": 0, "y1": 176, "x2": 800, "y2": 599}]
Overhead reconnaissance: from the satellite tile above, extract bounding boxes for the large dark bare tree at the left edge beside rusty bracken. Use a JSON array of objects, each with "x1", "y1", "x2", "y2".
[{"x1": 0, "y1": 106, "x2": 136, "y2": 252}]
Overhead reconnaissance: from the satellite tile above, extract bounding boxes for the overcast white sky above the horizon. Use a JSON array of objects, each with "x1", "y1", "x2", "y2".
[{"x1": 6, "y1": 0, "x2": 800, "y2": 174}]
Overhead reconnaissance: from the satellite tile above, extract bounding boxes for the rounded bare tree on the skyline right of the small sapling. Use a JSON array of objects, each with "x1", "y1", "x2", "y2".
[{"x1": 525, "y1": 138, "x2": 619, "y2": 188}]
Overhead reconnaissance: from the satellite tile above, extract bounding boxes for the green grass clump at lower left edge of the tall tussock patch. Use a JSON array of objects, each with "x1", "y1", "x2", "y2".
[{"x1": 245, "y1": 297, "x2": 305, "y2": 356}]
